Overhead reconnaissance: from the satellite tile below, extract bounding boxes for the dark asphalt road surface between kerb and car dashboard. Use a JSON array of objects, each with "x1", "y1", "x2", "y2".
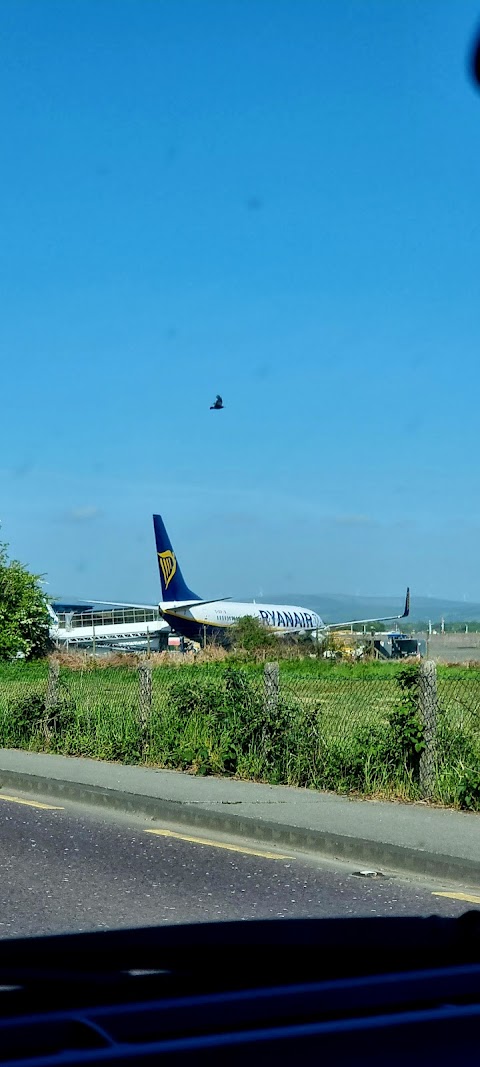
[{"x1": 0, "y1": 794, "x2": 480, "y2": 937}]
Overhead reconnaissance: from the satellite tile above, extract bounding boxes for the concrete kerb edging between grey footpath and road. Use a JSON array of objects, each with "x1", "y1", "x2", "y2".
[{"x1": 0, "y1": 769, "x2": 480, "y2": 888}]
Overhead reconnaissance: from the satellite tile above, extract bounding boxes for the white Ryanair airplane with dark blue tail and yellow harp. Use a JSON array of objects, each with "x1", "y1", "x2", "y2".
[{"x1": 154, "y1": 515, "x2": 410, "y2": 641}]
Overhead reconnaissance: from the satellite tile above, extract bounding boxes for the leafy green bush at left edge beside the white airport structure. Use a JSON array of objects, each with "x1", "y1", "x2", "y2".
[{"x1": 0, "y1": 543, "x2": 50, "y2": 659}]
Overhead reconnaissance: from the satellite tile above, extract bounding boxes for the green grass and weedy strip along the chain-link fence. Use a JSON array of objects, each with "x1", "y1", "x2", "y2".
[{"x1": 0, "y1": 660, "x2": 480, "y2": 810}]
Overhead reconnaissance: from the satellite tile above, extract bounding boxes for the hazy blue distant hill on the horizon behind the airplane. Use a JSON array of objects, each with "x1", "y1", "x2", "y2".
[{"x1": 257, "y1": 593, "x2": 480, "y2": 622}]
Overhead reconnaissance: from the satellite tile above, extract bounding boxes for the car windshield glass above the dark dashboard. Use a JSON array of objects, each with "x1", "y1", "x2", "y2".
[{"x1": 0, "y1": 0, "x2": 480, "y2": 937}]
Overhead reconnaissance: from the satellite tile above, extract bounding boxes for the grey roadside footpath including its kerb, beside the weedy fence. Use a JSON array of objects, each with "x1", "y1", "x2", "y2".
[{"x1": 0, "y1": 749, "x2": 480, "y2": 887}]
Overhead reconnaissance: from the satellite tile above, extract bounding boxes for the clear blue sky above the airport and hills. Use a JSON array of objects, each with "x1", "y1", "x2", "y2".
[{"x1": 0, "y1": 0, "x2": 480, "y2": 601}]
